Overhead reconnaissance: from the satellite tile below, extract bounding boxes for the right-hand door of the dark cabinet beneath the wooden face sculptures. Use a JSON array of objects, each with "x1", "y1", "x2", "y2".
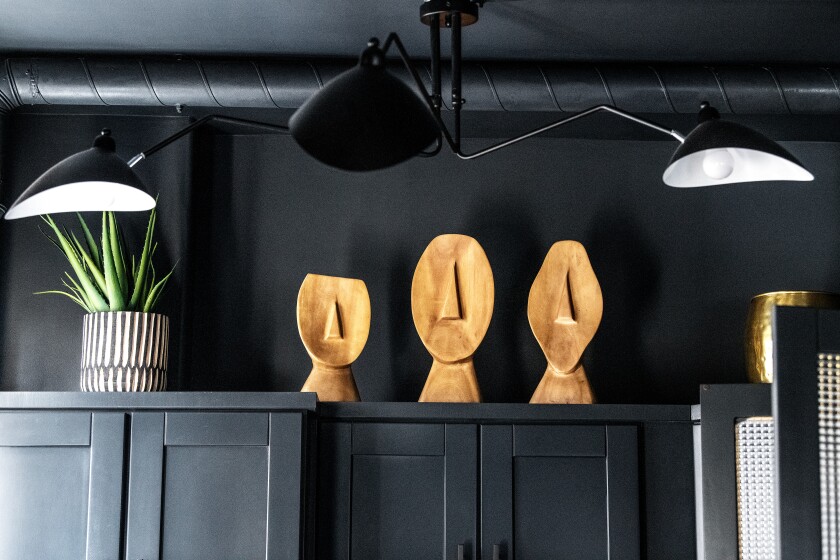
[{"x1": 481, "y1": 425, "x2": 640, "y2": 560}]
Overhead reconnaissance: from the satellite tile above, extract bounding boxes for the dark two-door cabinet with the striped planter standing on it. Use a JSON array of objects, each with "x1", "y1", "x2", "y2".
[{"x1": 0, "y1": 393, "x2": 315, "y2": 560}]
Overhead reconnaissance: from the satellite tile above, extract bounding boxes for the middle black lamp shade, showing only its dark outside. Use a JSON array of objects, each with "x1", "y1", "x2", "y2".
[{"x1": 289, "y1": 63, "x2": 440, "y2": 171}]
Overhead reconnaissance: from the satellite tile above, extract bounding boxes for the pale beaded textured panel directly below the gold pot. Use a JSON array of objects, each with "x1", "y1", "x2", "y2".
[{"x1": 735, "y1": 417, "x2": 776, "y2": 560}]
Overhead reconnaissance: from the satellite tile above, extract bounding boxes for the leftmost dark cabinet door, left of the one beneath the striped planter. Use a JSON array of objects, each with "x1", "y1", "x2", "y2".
[{"x1": 0, "y1": 411, "x2": 126, "y2": 560}]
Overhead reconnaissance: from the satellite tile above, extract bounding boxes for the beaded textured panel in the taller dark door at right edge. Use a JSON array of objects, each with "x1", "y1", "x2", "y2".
[{"x1": 817, "y1": 354, "x2": 840, "y2": 560}]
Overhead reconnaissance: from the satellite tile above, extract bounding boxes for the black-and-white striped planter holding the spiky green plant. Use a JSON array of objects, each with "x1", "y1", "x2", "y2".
[{"x1": 82, "y1": 311, "x2": 169, "y2": 391}]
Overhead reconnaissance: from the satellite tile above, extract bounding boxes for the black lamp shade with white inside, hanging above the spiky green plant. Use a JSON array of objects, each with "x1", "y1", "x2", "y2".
[{"x1": 5, "y1": 135, "x2": 155, "y2": 220}]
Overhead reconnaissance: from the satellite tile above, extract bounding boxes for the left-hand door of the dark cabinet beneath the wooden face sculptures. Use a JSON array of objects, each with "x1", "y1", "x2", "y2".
[{"x1": 317, "y1": 422, "x2": 478, "y2": 560}]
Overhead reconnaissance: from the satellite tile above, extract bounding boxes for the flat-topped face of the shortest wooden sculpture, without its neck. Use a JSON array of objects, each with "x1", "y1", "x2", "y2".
[{"x1": 297, "y1": 274, "x2": 370, "y2": 367}]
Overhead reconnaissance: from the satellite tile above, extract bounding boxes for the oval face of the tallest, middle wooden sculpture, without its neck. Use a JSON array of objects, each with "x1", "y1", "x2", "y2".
[{"x1": 411, "y1": 234, "x2": 494, "y2": 362}]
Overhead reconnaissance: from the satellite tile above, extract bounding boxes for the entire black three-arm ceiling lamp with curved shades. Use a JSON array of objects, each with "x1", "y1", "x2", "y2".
[{"x1": 5, "y1": 0, "x2": 814, "y2": 220}]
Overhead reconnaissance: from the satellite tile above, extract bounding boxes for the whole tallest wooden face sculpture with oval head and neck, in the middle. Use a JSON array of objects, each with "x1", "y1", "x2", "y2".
[{"x1": 411, "y1": 234, "x2": 494, "y2": 402}]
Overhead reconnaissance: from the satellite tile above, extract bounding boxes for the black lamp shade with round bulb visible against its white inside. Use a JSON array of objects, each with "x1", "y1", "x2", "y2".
[{"x1": 662, "y1": 118, "x2": 814, "y2": 187}]
